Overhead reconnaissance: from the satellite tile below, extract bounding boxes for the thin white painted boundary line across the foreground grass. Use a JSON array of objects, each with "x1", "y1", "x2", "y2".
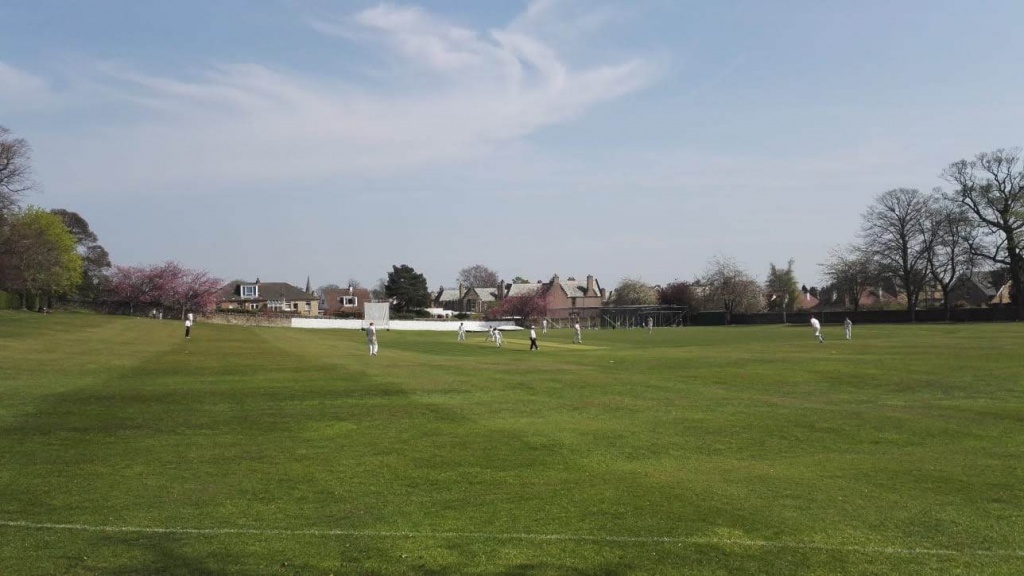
[{"x1": 0, "y1": 520, "x2": 1024, "y2": 558}]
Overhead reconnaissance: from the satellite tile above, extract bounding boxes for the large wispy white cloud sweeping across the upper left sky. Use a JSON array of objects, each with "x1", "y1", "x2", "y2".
[{"x1": 28, "y1": 2, "x2": 657, "y2": 191}]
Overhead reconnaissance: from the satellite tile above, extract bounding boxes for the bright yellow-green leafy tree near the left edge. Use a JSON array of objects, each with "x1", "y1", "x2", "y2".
[{"x1": 0, "y1": 206, "x2": 82, "y2": 306}]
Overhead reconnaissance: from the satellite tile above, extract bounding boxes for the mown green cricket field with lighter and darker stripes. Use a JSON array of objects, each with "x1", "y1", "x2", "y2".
[{"x1": 0, "y1": 313, "x2": 1024, "y2": 575}]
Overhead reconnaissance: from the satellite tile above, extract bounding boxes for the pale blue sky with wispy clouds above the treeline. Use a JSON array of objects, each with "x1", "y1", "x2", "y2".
[{"x1": 0, "y1": 0, "x2": 1024, "y2": 290}]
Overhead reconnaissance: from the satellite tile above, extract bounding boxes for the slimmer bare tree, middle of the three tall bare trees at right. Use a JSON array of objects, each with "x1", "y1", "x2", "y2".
[{"x1": 928, "y1": 196, "x2": 980, "y2": 320}]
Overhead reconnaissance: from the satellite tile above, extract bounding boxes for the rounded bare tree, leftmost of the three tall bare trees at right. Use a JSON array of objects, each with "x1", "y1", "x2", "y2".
[{"x1": 860, "y1": 188, "x2": 932, "y2": 322}]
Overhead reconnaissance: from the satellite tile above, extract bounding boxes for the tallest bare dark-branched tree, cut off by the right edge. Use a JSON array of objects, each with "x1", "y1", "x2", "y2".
[{"x1": 942, "y1": 149, "x2": 1024, "y2": 314}]
